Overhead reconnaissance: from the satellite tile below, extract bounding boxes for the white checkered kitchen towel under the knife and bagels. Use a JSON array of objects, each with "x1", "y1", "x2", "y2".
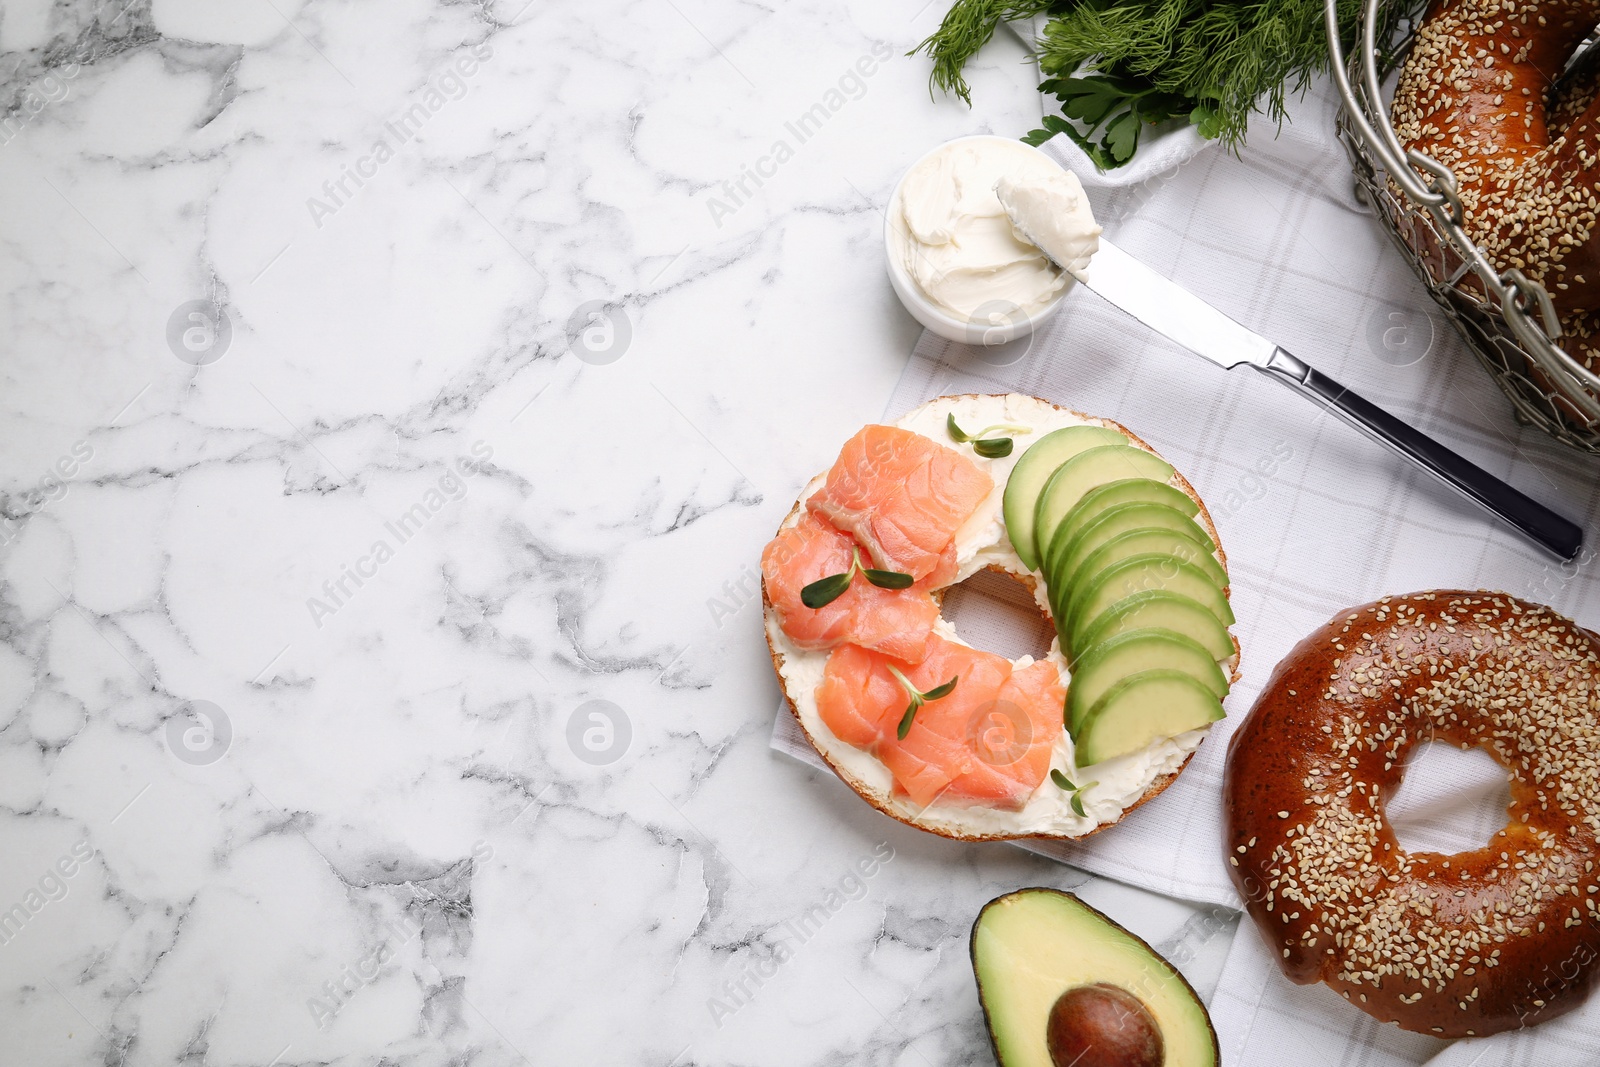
[{"x1": 773, "y1": 47, "x2": 1600, "y2": 1067}]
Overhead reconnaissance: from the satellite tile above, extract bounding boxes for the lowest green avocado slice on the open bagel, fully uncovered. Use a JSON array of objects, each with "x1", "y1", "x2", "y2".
[{"x1": 1074, "y1": 667, "x2": 1224, "y2": 768}]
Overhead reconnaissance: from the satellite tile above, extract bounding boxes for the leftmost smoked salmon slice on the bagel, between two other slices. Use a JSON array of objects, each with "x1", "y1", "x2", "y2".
[{"x1": 762, "y1": 514, "x2": 939, "y2": 662}]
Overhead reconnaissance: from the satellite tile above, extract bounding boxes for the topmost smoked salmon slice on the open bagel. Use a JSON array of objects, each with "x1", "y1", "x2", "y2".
[{"x1": 806, "y1": 426, "x2": 994, "y2": 585}]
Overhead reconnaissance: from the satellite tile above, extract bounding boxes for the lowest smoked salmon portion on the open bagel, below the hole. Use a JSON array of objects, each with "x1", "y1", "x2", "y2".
[{"x1": 816, "y1": 635, "x2": 1066, "y2": 808}]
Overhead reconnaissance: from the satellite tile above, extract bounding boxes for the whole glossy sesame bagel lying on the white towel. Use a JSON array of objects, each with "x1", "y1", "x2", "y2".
[{"x1": 1224, "y1": 590, "x2": 1600, "y2": 1038}]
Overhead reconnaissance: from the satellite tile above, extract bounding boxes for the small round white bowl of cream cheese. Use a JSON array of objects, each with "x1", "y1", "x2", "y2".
[{"x1": 885, "y1": 136, "x2": 1099, "y2": 344}]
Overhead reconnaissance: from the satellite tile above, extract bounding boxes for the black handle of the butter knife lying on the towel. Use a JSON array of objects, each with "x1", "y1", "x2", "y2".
[{"x1": 1259, "y1": 349, "x2": 1584, "y2": 560}]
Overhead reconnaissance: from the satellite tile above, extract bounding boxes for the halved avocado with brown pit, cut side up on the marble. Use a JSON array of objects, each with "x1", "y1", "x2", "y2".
[{"x1": 971, "y1": 889, "x2": 1221, "y2": 1067}]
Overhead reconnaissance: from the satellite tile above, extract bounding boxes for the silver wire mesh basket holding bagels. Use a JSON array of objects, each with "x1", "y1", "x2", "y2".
[{"x1": 1325, "y1": 0, "x2": 1600, "y2": 454}]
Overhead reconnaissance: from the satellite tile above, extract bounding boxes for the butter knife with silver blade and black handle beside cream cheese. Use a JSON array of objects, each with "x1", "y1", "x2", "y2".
[{"x1": 1080, "y1": 237, "x2": 1584, "y2": 560}]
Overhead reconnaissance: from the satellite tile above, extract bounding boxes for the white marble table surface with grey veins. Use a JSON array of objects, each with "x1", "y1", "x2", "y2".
[{"x1": 0, "y1": 0, "x2": 1234, "y2": 1067}]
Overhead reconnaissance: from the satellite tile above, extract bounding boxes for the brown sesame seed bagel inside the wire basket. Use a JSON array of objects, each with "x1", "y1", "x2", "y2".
[{"x1": 1392, "y1": 0, "x2": 1600, "y2": 375}]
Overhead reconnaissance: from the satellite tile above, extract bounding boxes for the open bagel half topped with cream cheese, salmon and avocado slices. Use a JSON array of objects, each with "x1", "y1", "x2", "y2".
[{"x1": 762, "y1": 394, "x2": 1238, "y2": 840}]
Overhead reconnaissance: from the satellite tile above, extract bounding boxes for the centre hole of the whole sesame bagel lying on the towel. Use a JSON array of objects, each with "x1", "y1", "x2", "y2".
[{"x1": 1384, "y1": 741, "x2": 1510, "y2": 854}]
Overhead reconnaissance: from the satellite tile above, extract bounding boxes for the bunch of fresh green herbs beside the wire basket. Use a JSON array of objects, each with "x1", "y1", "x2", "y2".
[{"x1": 915, "y1": 0, "x2": 1421, "y2": 170}]
